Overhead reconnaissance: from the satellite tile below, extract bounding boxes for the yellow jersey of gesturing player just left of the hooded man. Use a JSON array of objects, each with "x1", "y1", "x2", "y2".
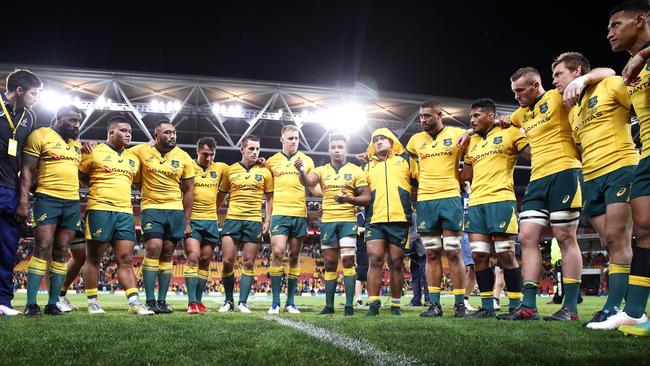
[{"x1": 312, "y1": 163, "x2": 368, "y2": 222}]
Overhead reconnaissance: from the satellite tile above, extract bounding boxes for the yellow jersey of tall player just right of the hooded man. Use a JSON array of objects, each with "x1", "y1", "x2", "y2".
[{"x1": 406, "y1": 126, "x2": 465, "y2": 201}]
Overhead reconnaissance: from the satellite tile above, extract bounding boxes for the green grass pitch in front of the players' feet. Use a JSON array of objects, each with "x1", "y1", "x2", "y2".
[{"x1": 0, "y1": 294, "x2": 650, "y2": 366}]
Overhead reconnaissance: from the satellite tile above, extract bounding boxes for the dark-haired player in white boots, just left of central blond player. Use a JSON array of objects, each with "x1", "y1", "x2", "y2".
[{"x1": 217, "y1": 135, "x2": 273, "y2": 314}]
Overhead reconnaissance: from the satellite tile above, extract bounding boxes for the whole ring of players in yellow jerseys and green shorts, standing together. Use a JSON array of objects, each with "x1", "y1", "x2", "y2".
[{"x1": 0, "y1": 1, "x2": 650, "y2": 335}]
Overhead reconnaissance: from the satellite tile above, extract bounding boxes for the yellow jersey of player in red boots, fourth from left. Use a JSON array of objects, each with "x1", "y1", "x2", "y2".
[{"x1": 191, "y1": 161, "x2": 228, "y2": 220}]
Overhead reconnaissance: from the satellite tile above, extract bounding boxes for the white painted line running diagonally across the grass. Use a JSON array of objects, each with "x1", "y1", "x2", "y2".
[{"x1": 264, "y1": 316, "x2": 422, "y2": 366}]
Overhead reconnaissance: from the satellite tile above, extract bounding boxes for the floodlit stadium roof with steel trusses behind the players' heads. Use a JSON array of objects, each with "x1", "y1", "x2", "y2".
[{"x1": 0, "y1": 64, "x2": 528, "y2": 176}]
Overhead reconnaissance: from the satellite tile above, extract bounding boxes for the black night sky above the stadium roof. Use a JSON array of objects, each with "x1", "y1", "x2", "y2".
[{"x1": 0, "y1": 0, "x2": 628, "y2": 103}]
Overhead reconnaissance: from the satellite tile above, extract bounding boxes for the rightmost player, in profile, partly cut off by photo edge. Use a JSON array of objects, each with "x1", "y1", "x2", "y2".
[{"x1": 607, "y1": 0, "x2": 650, "y2": 336}]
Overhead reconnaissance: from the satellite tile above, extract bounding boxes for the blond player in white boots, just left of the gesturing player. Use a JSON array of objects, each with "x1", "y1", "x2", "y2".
[{"x1": 266, "y1": 125, "x2": 314, "y2": 315}]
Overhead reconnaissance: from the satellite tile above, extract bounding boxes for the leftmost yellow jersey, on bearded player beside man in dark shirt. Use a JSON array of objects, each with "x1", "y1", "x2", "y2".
[{"x1": 23, "y1": 127, "x2": 81, "y2": 200}]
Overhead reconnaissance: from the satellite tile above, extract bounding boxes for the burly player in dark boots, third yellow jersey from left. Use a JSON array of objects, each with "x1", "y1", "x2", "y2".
[{"x1": 129, "y1": 120, "x2": 194, "y2": 314}]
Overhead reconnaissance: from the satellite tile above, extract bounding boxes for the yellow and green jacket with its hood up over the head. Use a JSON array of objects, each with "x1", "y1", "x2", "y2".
[{"x1": 363, "y1": 128, "x2": 415, "y2": 224}]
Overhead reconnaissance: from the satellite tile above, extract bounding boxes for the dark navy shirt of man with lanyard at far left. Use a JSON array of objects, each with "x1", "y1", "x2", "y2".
[{"x1": 0, "y1": 93, "x2": 36, "y2": 189}]
